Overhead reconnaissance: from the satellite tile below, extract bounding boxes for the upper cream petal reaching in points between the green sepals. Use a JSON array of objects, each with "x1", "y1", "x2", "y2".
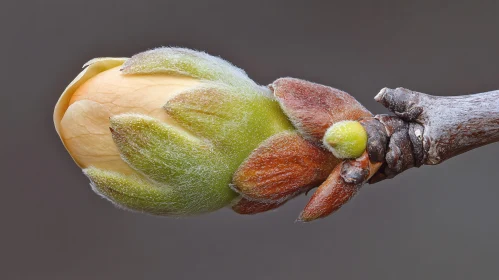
[{"x1": 69, "y1": 67, "x2": 199, "y2": 133}]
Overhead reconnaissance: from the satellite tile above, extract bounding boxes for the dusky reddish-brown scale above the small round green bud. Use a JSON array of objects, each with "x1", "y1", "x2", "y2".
[{"x1": 269, "y1": 78, "x2": 372, "y2": 142}]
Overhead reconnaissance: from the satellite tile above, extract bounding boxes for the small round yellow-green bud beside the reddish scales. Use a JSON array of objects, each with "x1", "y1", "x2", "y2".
[{"x1": 323, "y1": 121, "x2": 367, "y2": 158}]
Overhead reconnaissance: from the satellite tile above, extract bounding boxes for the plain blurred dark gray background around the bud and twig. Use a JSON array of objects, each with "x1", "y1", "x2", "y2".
[{"x1": 0, "y1": 0, "x2": 499, "y2": 279}]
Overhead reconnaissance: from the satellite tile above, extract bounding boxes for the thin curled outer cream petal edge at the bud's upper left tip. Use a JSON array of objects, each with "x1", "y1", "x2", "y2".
[{"x1": 54, "y1": 57, "x2": 128, "y2": 136}]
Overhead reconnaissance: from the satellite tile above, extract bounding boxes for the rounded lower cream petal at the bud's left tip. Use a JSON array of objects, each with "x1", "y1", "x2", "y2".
[{"x1": 60, "y1": 100, "x2": 134, "y2": 174}]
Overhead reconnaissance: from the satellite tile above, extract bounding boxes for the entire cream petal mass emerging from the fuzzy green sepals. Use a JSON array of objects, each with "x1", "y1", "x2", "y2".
[{"x1": 54, "y1": 58, "x2": 198, "y2": 173}]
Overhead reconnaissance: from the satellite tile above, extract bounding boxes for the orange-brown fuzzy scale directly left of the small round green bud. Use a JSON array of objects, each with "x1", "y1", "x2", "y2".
[{"x1": 233, "y1": 132, "x2": 340, "y2": 201}]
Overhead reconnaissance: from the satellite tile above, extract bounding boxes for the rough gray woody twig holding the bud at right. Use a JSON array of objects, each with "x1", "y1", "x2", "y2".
[{"x1": 366, "y1": 88, "x2": 499, "y2": 183}]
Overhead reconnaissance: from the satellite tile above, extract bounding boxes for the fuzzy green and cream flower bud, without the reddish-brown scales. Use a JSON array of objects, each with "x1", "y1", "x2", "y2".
[{"x1": 54, "y1": 48, "x2": 292, "y2": 215}]
